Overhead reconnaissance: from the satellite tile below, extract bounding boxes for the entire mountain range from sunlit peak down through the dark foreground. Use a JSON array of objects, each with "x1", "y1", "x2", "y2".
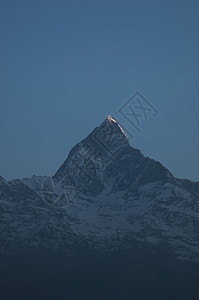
[{"x1": 0, "y1": 116, "x2": 199, "y2": 299}]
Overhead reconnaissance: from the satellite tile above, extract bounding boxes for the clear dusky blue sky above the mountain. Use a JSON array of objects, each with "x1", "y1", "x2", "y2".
[{"x1": 0, "y1": 0, "x2": 199, "y2": 181}]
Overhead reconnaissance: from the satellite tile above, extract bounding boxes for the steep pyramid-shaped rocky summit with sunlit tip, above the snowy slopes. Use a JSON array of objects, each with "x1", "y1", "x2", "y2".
[{"x1": 54, "y1": 116, "x2": 173, "y2": 196}]
